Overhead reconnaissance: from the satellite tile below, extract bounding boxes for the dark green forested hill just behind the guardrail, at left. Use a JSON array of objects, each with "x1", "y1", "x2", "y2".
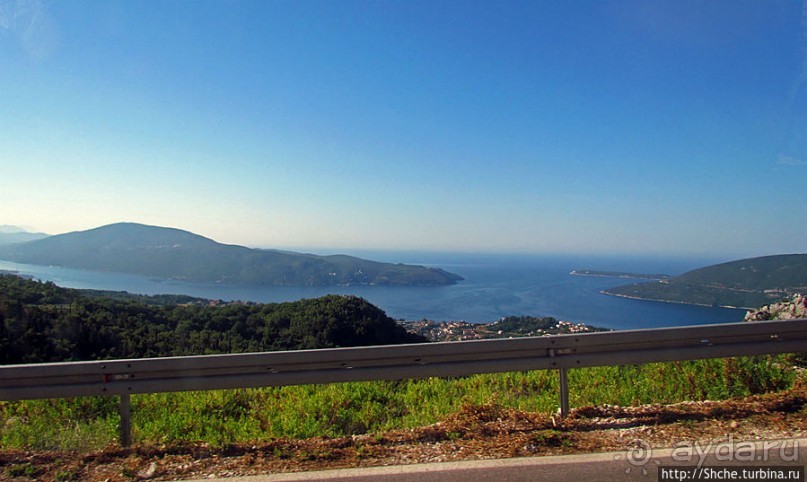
[{"x1": 0, "y1": 275, "x2": 425, "y2": 364}]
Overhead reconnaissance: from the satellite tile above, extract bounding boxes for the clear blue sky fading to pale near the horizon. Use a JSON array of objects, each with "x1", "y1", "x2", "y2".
[{"x1": 0, "y1": 0, "x2": 807, "y2": 257}]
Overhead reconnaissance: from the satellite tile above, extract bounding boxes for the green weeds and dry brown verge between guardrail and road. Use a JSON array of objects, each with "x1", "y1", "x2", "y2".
[{"x1": 0, "y1": 370, "x2": 807, "y2": 482}]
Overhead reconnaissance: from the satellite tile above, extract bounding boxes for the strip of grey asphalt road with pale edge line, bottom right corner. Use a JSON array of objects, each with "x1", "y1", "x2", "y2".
[{"x1": 188, "y1": 438, "x2": 807, "y2": 482}]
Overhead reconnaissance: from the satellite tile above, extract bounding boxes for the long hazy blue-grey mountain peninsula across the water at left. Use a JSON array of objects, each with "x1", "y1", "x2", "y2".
[{"x1": 0, "y1": 223, "x2": 463, "y2": 286}]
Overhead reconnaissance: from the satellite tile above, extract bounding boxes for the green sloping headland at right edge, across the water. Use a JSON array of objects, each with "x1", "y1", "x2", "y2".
[{"x1": 603, "y1": 254, "x2": 807, "y2": 309}]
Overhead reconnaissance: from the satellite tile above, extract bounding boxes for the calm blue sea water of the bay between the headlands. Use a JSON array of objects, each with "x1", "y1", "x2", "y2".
[{"x1": 0, "y1": 252, "x2": 745, "y2": 329}]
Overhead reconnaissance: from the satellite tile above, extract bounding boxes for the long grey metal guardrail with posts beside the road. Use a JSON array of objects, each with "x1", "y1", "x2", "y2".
[{"x1": 0, "y1": 319, "x2": 807, "y2": 445}]
